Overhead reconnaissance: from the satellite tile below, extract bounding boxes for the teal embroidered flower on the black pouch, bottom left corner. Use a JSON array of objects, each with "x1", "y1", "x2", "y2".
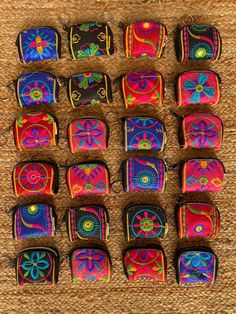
[{"x1": 21, "y1": 252, "x2": 50, "y2": 280}]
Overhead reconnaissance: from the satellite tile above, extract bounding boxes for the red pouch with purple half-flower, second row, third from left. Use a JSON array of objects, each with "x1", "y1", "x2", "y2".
[{"x1": 121, "y1": 71, "x2": 165, "y2": 109}]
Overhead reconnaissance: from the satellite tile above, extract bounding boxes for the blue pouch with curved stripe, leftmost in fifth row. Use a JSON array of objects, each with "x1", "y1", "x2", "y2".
[{"x1": 12, "y1": 203, "x2": 57, "y2": 240}]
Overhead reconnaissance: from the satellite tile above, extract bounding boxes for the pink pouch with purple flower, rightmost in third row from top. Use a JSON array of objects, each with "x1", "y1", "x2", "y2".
[{"x1": 178, "y1": 113, "x2": 223, "y2": 150}]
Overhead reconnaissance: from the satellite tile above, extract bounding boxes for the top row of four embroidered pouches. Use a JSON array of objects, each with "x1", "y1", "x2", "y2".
[{"x1": 16, "y1": 21, "x2": 221, "y2": 63}]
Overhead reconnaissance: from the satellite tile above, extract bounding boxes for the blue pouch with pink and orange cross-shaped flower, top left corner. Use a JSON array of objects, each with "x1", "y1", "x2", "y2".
[{"x1": 16, "y1": 26, "x2": 61, "y2": 63}]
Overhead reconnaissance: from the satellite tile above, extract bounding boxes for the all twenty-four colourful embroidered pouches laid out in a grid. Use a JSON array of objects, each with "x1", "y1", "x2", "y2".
[{"x1": 9, "y1": 21, "x2": 225, "y2": 286}]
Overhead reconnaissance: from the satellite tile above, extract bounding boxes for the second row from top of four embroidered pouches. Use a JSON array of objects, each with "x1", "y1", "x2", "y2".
[{"x1": 10, "y1": 70, "x2": 221, "y2": 108}]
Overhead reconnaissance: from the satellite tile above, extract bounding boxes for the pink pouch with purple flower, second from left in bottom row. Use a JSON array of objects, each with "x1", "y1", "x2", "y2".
[{"x1": 70, "y1": 245, "x2": 112, "y2": 283}]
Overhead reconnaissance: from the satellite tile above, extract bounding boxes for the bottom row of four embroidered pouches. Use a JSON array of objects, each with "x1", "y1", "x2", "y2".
[{"x1": 15, "y1": 244, "x2": 218, "y2": 286}]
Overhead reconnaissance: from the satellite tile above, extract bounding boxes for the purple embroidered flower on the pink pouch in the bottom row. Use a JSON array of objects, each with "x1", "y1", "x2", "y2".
[{"x1": 76, "y1": 249, "x2": 104, "y2": 273}]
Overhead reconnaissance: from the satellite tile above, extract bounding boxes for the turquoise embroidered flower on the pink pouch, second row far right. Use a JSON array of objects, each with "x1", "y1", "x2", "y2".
[{"x1": 184, "y1": 73, "x2": 215, "y2": 104}]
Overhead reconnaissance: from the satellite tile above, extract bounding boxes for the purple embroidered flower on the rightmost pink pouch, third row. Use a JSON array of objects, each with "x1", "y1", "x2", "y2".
[{"x1": 190, "y1": 120, "x2": 217, "y2": 147}]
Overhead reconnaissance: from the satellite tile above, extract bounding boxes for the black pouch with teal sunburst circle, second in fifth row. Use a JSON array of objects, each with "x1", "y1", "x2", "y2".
[{"x1": 66, "y1": 205, "x2": 109, "y2": 242}]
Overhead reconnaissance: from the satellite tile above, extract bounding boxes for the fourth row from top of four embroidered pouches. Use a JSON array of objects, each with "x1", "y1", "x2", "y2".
[{"x1": 12, "y1": 157, "x2": 225, "y2": 198}]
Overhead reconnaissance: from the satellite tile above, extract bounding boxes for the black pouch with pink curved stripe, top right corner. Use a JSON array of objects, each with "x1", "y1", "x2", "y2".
[{"x1": 175, "y1": 25, "x2": 221, "y2": 62}]
